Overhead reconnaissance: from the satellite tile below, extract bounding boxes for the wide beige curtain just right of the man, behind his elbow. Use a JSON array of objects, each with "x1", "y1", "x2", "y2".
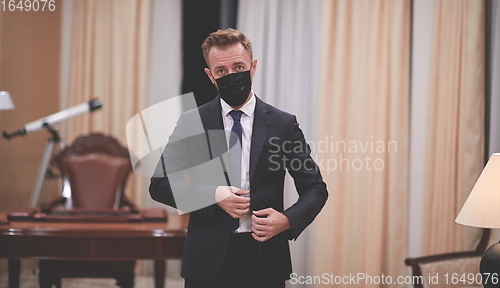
[{"x1": 314, "y1": 0, "x2": 410, "y2": 287}]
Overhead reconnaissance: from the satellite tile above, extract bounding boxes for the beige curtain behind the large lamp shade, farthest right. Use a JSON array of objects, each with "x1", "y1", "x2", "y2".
[{"x1": 423, "y1": 0, "x2": 484, "y2": 254}]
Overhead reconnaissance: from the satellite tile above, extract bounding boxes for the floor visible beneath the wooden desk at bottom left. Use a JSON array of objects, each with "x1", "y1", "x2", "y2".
[{"x1": 0, "y1": 270, "x2": 184, "y2": 288}]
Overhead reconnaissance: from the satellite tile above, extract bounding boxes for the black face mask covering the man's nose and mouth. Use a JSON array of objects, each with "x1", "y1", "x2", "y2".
[{"x1": 215, "y1": 70, "x2": 252, "y2": 107}]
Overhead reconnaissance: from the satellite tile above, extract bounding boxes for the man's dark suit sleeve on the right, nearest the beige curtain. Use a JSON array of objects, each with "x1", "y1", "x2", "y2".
[{"x1": 283, "y1": 116, "x2": 328, "y2": 239}]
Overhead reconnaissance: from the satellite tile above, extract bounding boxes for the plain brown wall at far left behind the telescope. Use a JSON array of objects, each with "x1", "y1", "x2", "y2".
[{"x1": 0, "y1": 5, "x2": 61, "y2": 272}]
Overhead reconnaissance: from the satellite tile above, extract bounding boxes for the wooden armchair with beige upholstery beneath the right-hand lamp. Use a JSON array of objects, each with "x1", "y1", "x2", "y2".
[{"x1": 405, "y1": 229, "x2": 499, "y2": 288}]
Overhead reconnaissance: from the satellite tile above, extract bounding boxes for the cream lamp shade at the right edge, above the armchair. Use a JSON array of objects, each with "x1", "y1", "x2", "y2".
[{"x1": 455, "y1": 153, "x2": 500, "y2": 228}]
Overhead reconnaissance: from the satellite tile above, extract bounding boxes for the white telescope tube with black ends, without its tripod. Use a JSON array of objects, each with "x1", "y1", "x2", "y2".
[{"x1": 3, "y1": 99, "x2": 102, "y2": 139}]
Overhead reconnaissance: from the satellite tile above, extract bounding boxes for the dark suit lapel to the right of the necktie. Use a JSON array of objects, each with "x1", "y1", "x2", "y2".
[{"x1": 250, "y1": 96, "x2": 272, "y2": 181}]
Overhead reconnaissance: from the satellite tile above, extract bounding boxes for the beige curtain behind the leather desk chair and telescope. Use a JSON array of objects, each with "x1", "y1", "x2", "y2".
[{"x1": 66, "y1": 0, "x2": 150, "y2": 205}]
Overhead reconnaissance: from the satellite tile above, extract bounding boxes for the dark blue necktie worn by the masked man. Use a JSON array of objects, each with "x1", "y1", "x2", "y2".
[{"x1": 229, "y1": 110, "x2": 243, "y2": 231}]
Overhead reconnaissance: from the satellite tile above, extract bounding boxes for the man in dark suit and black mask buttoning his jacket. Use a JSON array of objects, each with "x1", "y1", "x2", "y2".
[{"x1": 149, "y1": 29, "x2": 328, "y2": 288}]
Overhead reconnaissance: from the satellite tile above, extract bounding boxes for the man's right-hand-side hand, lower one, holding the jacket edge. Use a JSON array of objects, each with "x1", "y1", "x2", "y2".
[{"x1": 252, "y1": 208, "x2": 292, "y2": 242}]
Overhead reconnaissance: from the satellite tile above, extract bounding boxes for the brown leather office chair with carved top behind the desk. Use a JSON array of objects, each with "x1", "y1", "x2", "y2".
[{"x1": 39, "y1": 133, "x2": 136, "y2": 288}]
